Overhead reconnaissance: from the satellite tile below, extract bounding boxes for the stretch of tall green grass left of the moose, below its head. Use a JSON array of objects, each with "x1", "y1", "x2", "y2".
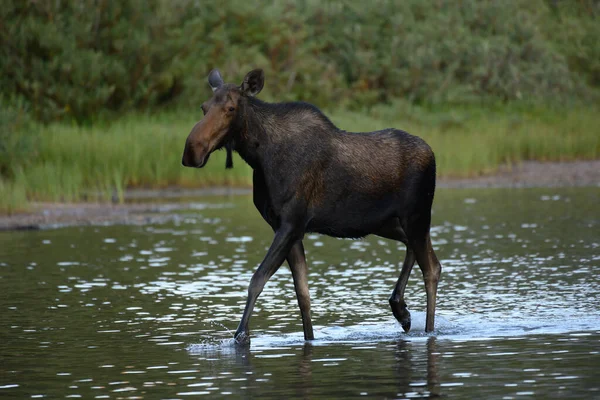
[{"x1": 16, "y1": 111, "x2": 250, "y2": 201}]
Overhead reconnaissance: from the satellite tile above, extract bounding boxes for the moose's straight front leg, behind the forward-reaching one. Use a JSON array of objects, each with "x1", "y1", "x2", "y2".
[{"x1": 287, "y1": 240, "x2": 314, "y2": 340}]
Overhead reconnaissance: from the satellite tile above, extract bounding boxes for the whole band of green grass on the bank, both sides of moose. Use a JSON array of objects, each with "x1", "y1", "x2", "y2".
[{"x1": 0, "y1": 102, "x2": 600, "y2": 213}]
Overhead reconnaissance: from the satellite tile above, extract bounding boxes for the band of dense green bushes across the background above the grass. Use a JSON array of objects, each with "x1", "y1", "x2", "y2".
[{"x1": 0, "y1": 0, "x2": 600, "y2": 122}]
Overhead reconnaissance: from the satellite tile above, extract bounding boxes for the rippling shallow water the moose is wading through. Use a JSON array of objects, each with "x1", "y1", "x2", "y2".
[{"x1": 0, "y1": 188, "x2": 600, "y2": 399}]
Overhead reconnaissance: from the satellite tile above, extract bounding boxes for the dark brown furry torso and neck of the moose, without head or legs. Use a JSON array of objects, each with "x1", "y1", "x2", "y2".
[{"x1": 233, "y1": 98, "x2": 435, "y2": 238}]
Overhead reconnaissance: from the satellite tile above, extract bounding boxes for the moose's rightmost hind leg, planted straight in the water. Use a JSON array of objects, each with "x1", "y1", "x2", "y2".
[{"x1": 413, "y1": 233, "x2": 442, "y2": 332}]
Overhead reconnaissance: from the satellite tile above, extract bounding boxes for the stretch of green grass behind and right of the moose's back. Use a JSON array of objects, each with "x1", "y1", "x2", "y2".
[{"x1": 333, "y1": 103, "x2": 600, "y2": 177}]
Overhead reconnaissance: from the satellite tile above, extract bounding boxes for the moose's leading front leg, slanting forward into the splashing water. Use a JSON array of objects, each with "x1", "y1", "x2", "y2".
[{"x1": 235, "y1": 225, "x2": 301, "y2": 344}]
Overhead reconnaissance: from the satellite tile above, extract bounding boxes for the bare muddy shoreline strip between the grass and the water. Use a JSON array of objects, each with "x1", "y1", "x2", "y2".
[{"x1": 0, "y1": 160, "x2": 600, "y2": 230}]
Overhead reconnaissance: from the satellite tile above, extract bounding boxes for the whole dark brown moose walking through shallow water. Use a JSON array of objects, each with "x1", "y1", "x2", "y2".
[{"x1": 182, "y1": 69, "x2": 441, "y2": 344}]
